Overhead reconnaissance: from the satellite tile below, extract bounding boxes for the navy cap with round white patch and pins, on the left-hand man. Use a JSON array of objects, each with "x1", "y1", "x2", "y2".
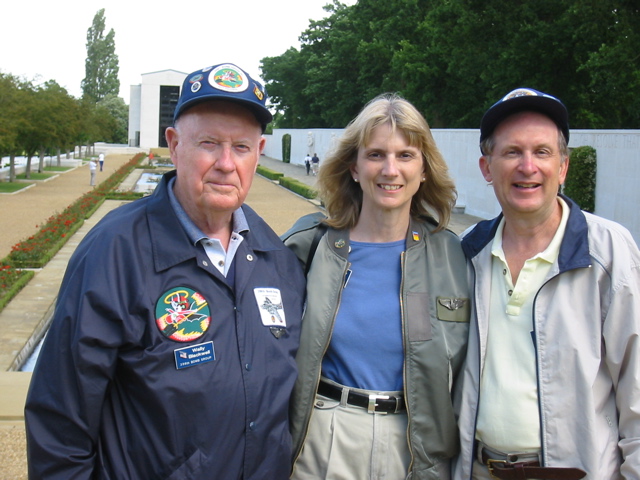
[{"x1": 173, "y1": 63, "x2": 273, "y2": 132}]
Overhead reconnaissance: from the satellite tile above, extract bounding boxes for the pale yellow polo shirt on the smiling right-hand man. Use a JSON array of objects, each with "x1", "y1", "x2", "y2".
[{"x1": 476, "y1": 197, "x2": 569, "y2": 453}]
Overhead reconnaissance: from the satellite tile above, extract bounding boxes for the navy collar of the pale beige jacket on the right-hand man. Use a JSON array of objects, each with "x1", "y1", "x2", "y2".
[{"x1": 462, "y1": 195, "x2": 591, "y2": 272}]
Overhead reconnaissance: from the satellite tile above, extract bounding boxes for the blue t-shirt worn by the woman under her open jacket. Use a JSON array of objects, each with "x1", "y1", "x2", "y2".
[{"x1": 322, "y1": 240, "x2": 405, "y2": 391}]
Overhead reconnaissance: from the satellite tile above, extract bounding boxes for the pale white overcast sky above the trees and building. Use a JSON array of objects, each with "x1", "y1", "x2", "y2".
[{"x1": 0, "y1": 0, "x2": 356, "y2": 104}]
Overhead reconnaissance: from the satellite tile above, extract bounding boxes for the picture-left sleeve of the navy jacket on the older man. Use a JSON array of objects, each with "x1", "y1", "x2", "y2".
[{"x1": 25, "y1": 244, "x2": 129, "y2": 480}]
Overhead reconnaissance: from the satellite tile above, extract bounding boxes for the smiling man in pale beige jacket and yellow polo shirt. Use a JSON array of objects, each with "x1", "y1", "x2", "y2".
[{"x1": 454, "y1": 89, "x2": 640, "y2": 480}]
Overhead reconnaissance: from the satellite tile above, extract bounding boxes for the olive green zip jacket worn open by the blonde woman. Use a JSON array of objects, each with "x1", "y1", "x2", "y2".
[{"x1": 282, "y1": 214, "x2": 469, "y2": 480}]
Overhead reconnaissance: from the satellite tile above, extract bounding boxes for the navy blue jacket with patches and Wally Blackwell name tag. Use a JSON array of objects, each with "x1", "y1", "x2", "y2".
[{"x1": 25, "y1": 172, "x2": 305, "y2": 480}]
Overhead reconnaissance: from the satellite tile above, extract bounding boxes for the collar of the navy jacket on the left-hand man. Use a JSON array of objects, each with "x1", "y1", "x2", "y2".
[{"x1": 147, "y1": 170, "x2": 282, "y2": 271}]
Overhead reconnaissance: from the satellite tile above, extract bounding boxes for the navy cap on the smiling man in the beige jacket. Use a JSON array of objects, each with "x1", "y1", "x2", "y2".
[{"x1": 480, "y1": 88, "x2": 569, "y2": 143}]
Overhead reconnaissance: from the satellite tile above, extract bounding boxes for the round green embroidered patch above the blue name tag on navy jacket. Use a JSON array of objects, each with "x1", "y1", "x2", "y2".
[{"x1": 156, "y1": 287, "x2": 211, "y2": 342}]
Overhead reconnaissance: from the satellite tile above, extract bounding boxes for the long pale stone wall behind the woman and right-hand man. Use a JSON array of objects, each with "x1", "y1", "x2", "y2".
[{"x1": 265, "y1": 129, "x2": 640, "y2": 244}]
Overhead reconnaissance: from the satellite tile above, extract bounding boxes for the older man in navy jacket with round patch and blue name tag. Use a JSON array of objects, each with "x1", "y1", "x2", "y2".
[{"x1": 26, "y1": 64, "x2": 305, "y2": 480}]
